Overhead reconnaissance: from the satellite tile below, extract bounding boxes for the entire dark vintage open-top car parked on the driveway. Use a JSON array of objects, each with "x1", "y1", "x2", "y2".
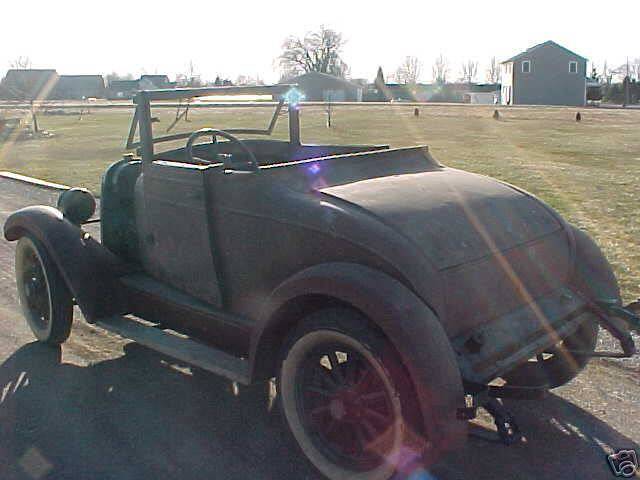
[{"x1": 4, "y1": 86, "x2": 639, "y2": 479}]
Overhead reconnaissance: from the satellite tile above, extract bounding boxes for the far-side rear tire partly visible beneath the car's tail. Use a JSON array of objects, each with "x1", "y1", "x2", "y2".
[{"x1": 503, "y1": 319, "x2": 598, "y2": 388}]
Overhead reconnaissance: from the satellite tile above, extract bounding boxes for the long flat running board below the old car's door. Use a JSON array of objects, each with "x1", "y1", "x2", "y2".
[{"x1": 95, "y1": 316, "x2": 250, "y2": 385}]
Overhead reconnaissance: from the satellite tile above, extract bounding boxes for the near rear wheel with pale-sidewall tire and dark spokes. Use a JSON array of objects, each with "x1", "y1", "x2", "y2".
[{"x1": 277, "y1": 308, "x2": 419, "y2": 480}]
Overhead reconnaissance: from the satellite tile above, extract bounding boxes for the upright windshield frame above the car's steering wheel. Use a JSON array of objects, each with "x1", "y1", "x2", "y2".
[{"x1": 126, "y1": 84, "x2": 300, "y2": 162}]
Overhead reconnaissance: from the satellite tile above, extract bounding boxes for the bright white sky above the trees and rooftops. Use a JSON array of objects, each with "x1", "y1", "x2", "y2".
[{"x1": 0, "y1": 0, "x2": 640, "y2": 83}]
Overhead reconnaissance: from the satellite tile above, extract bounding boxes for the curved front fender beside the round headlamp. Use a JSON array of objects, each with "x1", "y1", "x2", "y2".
[{"x1": 4, "y1": 205, "x2": 125, "y2": 322}]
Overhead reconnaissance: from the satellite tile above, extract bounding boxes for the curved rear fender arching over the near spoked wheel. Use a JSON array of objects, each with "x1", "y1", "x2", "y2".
[{"x1": 250, "y1": 263, "x2": 467, "y2": 453}]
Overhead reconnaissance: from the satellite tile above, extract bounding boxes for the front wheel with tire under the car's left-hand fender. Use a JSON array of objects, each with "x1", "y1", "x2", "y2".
[{"x1": 15, "y1": 236, "x2": 73, "y2": 345}]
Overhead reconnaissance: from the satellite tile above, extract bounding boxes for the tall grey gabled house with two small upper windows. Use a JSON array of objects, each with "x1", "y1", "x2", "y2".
[{"x1": 501, "y1": 40, "x2": 587, "y2": 105}]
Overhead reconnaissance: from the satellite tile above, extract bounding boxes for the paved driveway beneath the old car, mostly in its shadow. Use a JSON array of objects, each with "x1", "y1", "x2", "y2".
[{"x1": 0, "y1": 178, "x2": 640, "y2": 480}]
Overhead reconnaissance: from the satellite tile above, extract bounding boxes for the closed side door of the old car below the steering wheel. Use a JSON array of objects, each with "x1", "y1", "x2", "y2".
[{"x1": 141, "y1": 160, "x2": 221, "y2": 306}]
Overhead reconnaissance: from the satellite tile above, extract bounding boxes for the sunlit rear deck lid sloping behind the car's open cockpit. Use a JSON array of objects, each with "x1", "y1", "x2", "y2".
[{"x1": 320, "y1": 168, "x2": 562, "y2": 270}]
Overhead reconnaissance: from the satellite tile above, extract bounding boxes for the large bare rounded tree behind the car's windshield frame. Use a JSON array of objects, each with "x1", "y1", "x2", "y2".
[{"x1": 278, "y1": 26, "x2": 349, "y2": 77}]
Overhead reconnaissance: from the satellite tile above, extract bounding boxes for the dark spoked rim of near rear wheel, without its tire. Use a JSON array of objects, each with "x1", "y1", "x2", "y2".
[{"x1": 296, "y1": 344, "x2": 397, "y2": 470}]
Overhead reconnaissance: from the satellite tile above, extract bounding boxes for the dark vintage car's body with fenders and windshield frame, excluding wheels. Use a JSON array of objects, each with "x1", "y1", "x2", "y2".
[{"x1": 5, "y1": 86, "x2": 637, "y2": 478}]
